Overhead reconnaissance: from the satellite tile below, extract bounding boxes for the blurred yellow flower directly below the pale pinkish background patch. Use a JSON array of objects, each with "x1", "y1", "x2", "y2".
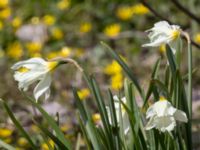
[{"x1": 26, "y1": 42, "x2": 43, "y2": 54}]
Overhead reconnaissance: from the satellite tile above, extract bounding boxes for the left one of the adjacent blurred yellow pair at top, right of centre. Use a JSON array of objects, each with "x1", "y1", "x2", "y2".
[{"x1": 116, "y1": 6, "x2": 133, "y2": 20}]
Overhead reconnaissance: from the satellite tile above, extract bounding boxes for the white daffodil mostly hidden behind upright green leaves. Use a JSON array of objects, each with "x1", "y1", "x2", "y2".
[{"x1": 106, "y1": 95, "x2": 130, "y2": 134}]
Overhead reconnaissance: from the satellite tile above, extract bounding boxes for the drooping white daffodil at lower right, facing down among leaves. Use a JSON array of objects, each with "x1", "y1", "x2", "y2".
[{"x1": 146, "y1": 97, "x2": 188, "y2": 132}]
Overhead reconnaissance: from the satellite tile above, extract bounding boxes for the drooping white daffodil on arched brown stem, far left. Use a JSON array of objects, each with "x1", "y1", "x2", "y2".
[{"x1": 11, "y1": 58, "x2": 59, "y2": 101}]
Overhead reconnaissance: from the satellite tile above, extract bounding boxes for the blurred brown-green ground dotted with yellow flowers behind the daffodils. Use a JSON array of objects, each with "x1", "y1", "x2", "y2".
[{"x1": 0, "y1": 0, "x2": 200, "y2": 150}]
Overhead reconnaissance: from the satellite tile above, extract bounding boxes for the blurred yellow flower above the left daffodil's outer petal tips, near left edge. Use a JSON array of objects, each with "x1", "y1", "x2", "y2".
[{"x1": 6, "y1": 42, "x2": 23, "y2": 59}]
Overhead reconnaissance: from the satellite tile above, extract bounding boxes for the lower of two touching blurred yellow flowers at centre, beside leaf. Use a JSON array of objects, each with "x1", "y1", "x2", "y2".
[{"x1": 111, "y1": 72, "x2": 123, "y2": 90}]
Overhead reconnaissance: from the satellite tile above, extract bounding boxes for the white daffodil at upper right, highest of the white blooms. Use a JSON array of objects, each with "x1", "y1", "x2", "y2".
[{"x1": 142, "y1": 21, "x2": 182, "y2": 53}]
